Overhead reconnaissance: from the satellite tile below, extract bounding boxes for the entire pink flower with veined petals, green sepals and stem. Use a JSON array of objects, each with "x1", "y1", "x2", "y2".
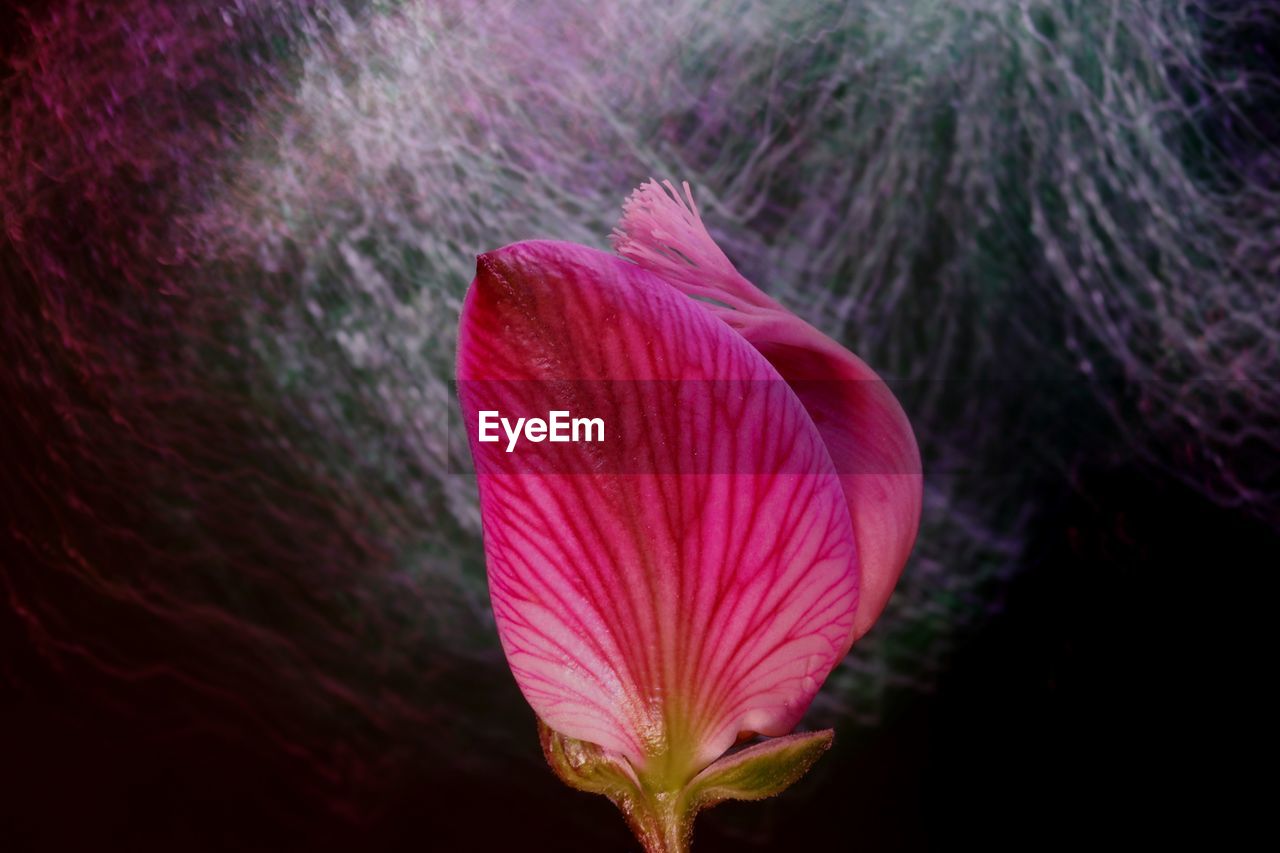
[{"x1": 458, "y1": 182, "x2": 922, "y2": 852}]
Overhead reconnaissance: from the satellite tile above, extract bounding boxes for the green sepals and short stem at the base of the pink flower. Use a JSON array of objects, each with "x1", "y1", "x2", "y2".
[{"x1": 538, "y1": 720, "x2": 835, "y2": 853}]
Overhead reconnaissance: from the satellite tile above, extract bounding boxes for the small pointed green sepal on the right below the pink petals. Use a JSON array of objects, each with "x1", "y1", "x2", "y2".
[{"x1": 684, "y1": 729, "x2": 835, "y2": 812}]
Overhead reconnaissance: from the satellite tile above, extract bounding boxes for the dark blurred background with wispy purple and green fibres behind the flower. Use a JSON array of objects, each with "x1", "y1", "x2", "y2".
[{"x1": 0, "y1": 0, "x2": 1280, "y2": 853}]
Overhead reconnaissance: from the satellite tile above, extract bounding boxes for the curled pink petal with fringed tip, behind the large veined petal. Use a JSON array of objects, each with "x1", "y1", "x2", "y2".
[{"x1": 613, "y1": 181, "x2": 923, "y2": 651}]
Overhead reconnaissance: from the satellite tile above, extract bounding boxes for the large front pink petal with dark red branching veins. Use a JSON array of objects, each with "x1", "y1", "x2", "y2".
[{"x1": 458, "y1": 236, "x2": 858, "y2": 788}]
